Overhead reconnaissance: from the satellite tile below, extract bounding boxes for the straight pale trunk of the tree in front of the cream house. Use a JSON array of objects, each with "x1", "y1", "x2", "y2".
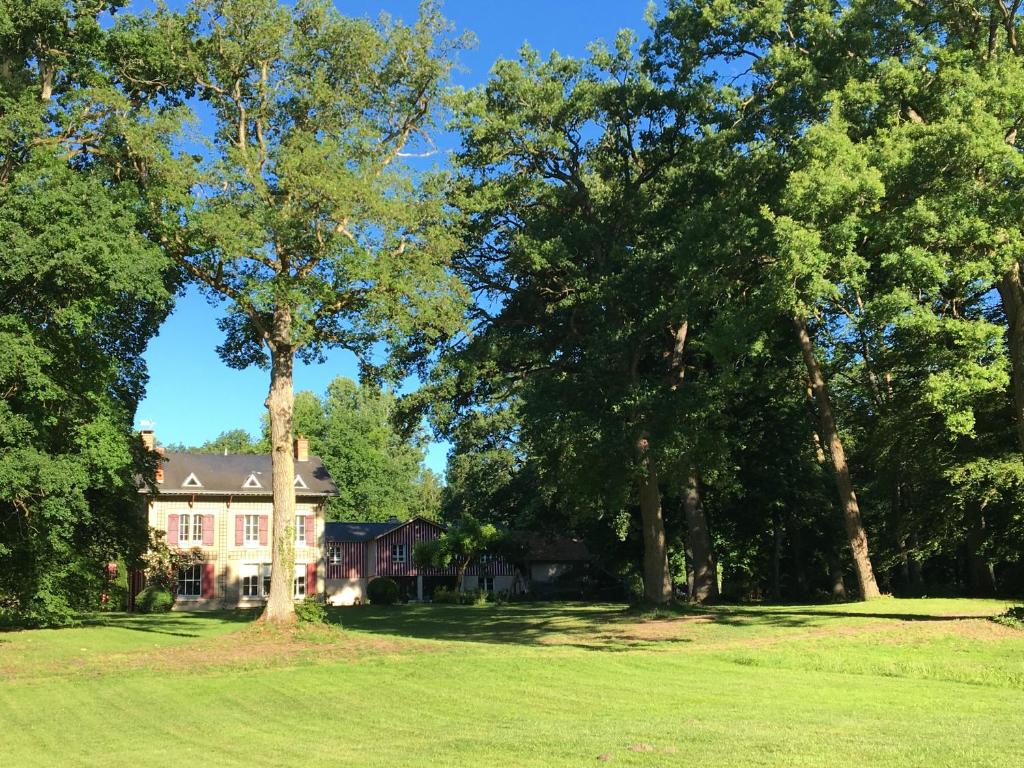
[{"x1": 262, "y1": 306, "x2": 295, "y2": 624}]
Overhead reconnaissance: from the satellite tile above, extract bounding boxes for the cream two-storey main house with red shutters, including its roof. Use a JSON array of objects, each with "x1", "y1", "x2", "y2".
[{"x1": 131, "y1": 430, "x2": 338, "y2": 610}]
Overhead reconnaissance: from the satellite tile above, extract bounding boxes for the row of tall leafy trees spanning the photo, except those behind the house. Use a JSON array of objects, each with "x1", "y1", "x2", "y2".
[{"x1": 0, "y1": 0, "x2": 1024, "y2": 621}]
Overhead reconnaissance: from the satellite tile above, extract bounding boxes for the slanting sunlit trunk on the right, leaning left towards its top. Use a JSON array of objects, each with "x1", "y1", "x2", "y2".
[{"x1": 793, "y1": 316, "x2": 881, "y2": 600}]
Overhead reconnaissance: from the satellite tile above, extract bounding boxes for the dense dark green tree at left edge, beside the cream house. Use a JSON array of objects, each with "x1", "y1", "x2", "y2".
[{"x1": 0, "y1": 1, "x2": 173, "y2": 624}]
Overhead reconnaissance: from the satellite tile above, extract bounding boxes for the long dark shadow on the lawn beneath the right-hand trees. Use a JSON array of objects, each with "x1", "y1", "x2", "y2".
[{"x1": 328, "y1": 603, "x2": 999, "y2": 651}]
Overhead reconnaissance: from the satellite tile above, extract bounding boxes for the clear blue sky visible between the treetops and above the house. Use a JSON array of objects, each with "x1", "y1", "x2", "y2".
[{"x1": 130, "y1": 0, "x2": 648, "y2": 473}]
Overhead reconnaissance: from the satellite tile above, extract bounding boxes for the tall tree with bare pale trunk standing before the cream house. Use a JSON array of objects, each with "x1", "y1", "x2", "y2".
[{"x1": 137, "y1": 0, "x2": 463, "y2": 622}]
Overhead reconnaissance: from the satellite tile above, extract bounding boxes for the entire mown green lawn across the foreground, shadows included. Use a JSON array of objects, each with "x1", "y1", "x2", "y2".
[{"x1": 0, "y1": 600, "x2": 1024, "y2": 768}]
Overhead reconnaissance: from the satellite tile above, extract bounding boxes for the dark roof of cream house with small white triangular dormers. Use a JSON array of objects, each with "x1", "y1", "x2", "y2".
[{"x1": 140, "y1": 453, "x2": 338, "y2": 497}]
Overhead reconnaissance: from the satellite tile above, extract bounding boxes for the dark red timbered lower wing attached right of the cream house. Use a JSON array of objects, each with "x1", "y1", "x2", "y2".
[{"x1": 324, "y1": 517, "x2": 521, "y2": 605}]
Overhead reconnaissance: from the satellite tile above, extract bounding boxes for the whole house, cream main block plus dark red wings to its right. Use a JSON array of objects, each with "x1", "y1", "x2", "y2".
[{"x1": 129, "y1": 430, "x2": 589, "y2": 610}]
